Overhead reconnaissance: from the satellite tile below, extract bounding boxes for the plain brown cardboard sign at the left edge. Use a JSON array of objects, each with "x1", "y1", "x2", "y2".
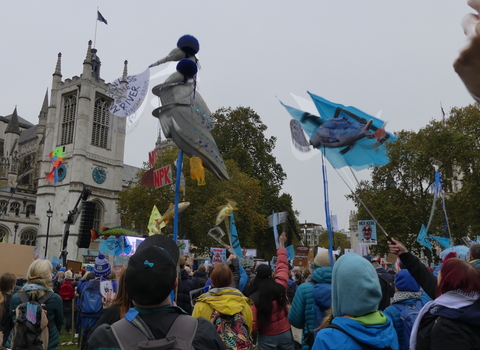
[{"x1": 0, "y1": 243, "x2": 35, "y2": 278}]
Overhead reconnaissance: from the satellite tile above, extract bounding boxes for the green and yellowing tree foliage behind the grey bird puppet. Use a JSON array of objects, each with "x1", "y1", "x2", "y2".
[{"x1": 117, "y1": 107, "x2": 296, "y2": 259}]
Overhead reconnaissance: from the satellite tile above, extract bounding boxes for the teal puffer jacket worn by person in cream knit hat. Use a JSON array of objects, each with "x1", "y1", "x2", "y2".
[{"x1": 288, "y1": 267, "x2": 332, "y2": 350}]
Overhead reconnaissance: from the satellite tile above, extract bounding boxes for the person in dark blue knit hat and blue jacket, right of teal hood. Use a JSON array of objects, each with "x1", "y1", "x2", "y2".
[{"x1": 384, "y1": 270, "x2": 432, "y2": 349}]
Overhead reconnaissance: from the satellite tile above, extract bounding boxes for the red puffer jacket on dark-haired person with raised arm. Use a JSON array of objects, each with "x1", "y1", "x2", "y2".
[{"x1": 250, "y1": 247, "x2": 290, "y2": 335}]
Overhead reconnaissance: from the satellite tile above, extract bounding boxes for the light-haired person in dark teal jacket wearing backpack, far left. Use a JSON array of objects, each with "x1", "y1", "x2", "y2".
[{"x1": 7, "y1": 260, "x2": 63, "y2": 350}]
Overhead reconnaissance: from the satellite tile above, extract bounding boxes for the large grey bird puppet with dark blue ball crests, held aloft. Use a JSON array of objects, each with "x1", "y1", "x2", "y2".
[{"x1": 151, "y1": 35, "x2": 229, "y2": 180}]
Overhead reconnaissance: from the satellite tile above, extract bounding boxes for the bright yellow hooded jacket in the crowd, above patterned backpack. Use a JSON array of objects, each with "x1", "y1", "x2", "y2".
[{"x1": 192, "y1": 287, "x2": 253, "y2": 333}]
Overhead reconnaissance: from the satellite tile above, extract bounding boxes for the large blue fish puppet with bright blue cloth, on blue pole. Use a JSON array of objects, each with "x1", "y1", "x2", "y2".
[{"x1": 282, "y1": 93, "x2": 397, "y2": 170}]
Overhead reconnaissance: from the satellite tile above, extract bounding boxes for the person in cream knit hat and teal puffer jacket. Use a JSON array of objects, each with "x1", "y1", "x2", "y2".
[{"x1": 288, "y1": 250, "x2": 332, "y2": 350}]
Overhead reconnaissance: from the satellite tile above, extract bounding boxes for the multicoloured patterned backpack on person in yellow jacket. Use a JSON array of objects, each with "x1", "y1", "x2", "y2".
[{"x1": 210, "y1": 310, "x2": 253, "y2": 350}]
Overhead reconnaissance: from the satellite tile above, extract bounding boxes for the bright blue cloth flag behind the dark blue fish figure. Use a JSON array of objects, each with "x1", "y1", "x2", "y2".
[{"x1": 282, "y1": 92, "x2": 397, "y2": 170}]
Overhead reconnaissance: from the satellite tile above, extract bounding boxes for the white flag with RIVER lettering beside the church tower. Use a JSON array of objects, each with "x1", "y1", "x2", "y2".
[{"x1": 107, "y1": 68, "x2": 150, "y2": 117}]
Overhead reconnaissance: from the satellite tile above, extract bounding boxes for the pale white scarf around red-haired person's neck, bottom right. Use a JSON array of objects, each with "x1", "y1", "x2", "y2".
[{"x1": 410, "y1": 290, "x2": 480, "y2": 350}]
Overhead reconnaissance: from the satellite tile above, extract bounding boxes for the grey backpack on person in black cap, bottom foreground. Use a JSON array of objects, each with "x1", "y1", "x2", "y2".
[{"x1": 112, "y1": 309, "x2": 198, "y2": 350}]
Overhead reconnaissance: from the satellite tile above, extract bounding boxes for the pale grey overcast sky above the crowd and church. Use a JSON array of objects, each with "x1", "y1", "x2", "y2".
[{"x1": 0, "y1": 0, "x2": 472, "y2": 229}]
